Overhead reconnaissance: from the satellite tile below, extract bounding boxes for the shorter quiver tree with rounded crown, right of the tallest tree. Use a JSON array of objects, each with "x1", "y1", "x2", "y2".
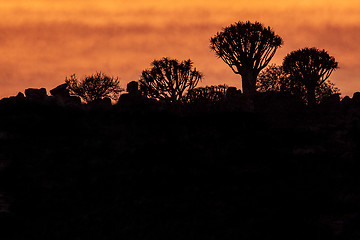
[{"x1": 283, "y1": 48, "x2": 338, "y2": 106}]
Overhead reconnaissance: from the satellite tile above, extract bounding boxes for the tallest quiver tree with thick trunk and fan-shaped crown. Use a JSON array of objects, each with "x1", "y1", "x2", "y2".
[{"x1": 210, "y1": 21, "x2": 283, "y2": 105}]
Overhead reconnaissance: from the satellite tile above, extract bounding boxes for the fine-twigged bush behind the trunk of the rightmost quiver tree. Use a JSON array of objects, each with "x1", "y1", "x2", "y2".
[{"x1": 256, "y1": 64, "x2": 340, "y2": 103}]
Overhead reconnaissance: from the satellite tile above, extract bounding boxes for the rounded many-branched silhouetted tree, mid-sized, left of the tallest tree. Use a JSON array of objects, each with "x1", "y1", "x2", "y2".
[{"x1": 139, "y1": 58, "x2": 203, "y2": 102}]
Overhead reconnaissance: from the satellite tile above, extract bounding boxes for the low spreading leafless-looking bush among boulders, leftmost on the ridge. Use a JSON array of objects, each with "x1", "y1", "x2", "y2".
[{"x1": 65, "y1": 72, "x2": 123, "y2": 103}]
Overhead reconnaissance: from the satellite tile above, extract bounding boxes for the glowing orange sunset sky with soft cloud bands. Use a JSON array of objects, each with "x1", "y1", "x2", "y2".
[{"x1": 0, "y1": 0, "x2": 360, "y2": 98}]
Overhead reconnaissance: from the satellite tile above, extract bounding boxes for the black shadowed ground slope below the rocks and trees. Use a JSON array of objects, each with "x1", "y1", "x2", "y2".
[{"x1": 0, "y1": 101, "x2": 360, "y2": 239}]
